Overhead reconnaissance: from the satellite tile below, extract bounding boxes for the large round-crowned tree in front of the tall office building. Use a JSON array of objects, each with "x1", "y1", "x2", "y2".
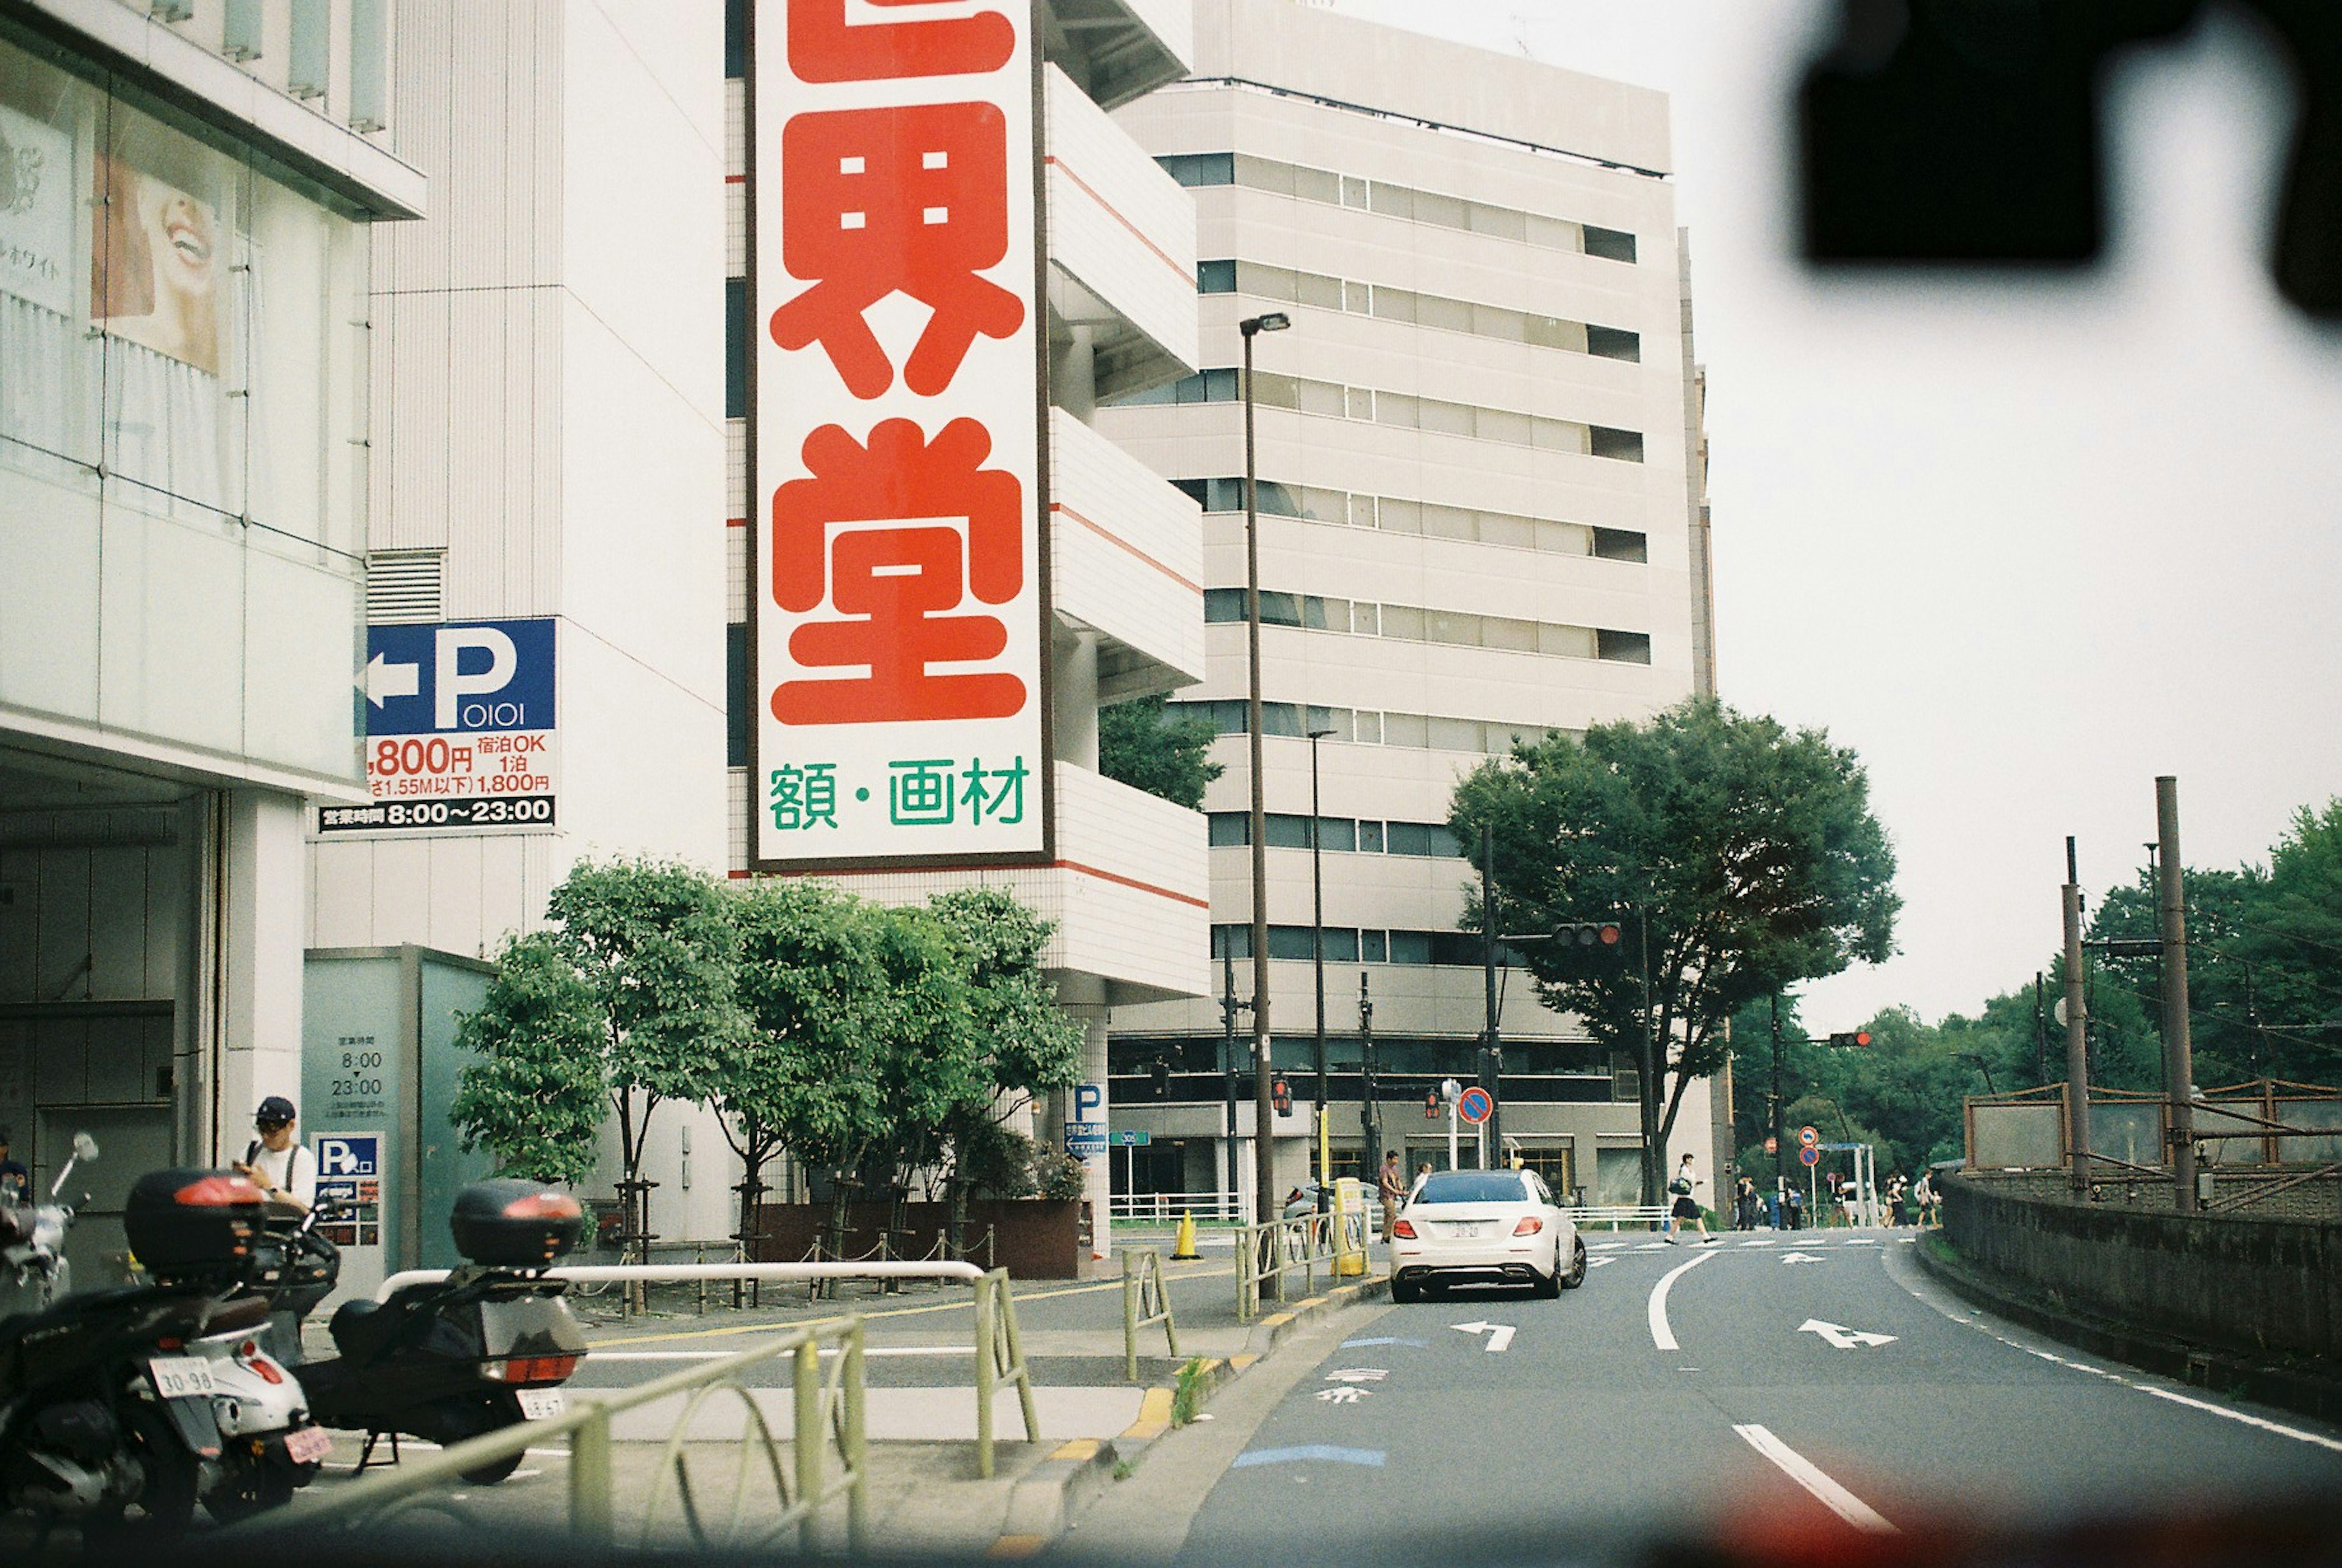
[{"x1": 1450, "y1": 700, "x2": 1899, "y2": 1203}]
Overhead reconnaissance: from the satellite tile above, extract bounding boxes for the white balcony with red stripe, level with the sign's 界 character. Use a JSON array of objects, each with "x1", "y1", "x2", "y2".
[{"x1": 1042, "y1": 65, "x2": 1199, "y2": 398}]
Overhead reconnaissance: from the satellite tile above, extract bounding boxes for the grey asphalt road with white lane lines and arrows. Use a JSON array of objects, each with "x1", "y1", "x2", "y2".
[{"x1": 1180, "y1": 1231, "x2": 2342, "y2": 1568}]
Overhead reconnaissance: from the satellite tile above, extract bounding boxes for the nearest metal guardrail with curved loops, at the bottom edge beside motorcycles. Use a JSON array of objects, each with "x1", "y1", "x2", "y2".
[{"x1": 232, "y1": 1317, "x2": 869, "y2": 1556}]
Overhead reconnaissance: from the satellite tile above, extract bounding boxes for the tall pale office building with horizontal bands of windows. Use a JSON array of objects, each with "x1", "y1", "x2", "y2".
[{"x1": 1096, "y1": 0, "x2": 1728, "y2": 1201}]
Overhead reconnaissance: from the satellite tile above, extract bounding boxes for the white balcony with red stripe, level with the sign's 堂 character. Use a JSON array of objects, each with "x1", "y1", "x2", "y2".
[{"x1": 1049, "y1": 410, "x2": 1204, "y2": 702}]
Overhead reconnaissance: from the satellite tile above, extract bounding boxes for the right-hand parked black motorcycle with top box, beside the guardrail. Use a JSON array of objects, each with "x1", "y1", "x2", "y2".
[{"x1": 295, "y1": 1180, "x2": 586, "y2": 1486}]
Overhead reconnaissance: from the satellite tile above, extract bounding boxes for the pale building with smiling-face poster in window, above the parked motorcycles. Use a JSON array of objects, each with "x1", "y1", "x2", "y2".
[{"x1": 0, "y1": 0, "x2": 426, "y2": 1280}]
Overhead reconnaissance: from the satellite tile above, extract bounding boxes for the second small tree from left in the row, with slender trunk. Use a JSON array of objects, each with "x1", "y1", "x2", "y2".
[{"x1": 546, "y1": 861, "x2": 742, "y2": 1233}]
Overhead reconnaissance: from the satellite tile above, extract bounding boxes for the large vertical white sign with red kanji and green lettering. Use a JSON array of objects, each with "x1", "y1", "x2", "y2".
[{"x1": 752, "y1": 0, "x2": 1049, "y2": 866}]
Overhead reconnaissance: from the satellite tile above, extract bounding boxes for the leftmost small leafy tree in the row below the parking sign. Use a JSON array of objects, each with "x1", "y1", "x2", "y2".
[{"x1": 447, "y1": 934, "x2": 607, "y2": 1187}]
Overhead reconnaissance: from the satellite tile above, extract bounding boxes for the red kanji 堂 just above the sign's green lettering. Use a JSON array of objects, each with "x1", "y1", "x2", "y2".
[{"x1": 773, "y1": 419, "x2": 1028, "y2": 723}]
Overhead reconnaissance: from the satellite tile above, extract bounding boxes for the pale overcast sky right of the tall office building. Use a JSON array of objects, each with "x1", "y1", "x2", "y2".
[{"x1": 1333, "y1": 0, "x2": 2342, "y2": 1028}]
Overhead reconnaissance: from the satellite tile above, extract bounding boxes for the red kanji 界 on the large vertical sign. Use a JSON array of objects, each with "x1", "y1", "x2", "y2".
[{"x1": 768, "y1": 103, "x2": 1026, "y2": 398}]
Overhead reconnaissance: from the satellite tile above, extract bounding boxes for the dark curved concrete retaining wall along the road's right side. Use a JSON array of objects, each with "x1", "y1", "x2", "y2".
[{"x1": 1941, "y1": 1175, "x2": 2342, "y2": 1359}]
